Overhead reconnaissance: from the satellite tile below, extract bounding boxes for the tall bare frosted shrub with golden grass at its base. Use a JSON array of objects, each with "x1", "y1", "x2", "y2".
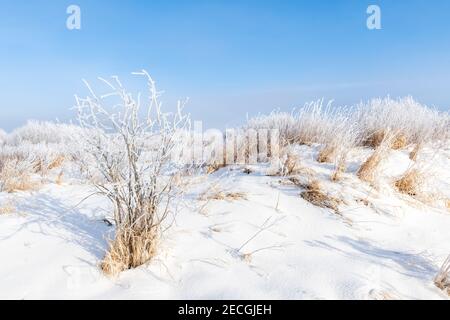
[{"x1": 76, "y1": 71, "x2": 189, "y2": 275}]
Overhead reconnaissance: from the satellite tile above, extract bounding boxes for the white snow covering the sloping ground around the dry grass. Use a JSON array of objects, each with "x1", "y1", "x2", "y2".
[{"x1": 0, "y1": 146, "x2": 450, "y2": 299}]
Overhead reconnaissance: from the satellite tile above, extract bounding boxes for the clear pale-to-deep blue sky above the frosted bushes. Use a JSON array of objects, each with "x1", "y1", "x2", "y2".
[{"x1": 0, "y1": 0, "x2": 450, "y2": 130}]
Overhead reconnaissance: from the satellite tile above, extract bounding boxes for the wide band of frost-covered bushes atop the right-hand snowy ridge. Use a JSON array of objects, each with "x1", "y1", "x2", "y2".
[{"x1": 246, "y1": 97, "x2": 450, "y2": 157}]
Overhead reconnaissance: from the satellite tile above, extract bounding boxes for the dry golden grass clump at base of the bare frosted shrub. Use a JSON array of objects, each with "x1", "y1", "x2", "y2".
[{"x1": 100, "y1": 228, "x2": 160, "y2": 277}]
